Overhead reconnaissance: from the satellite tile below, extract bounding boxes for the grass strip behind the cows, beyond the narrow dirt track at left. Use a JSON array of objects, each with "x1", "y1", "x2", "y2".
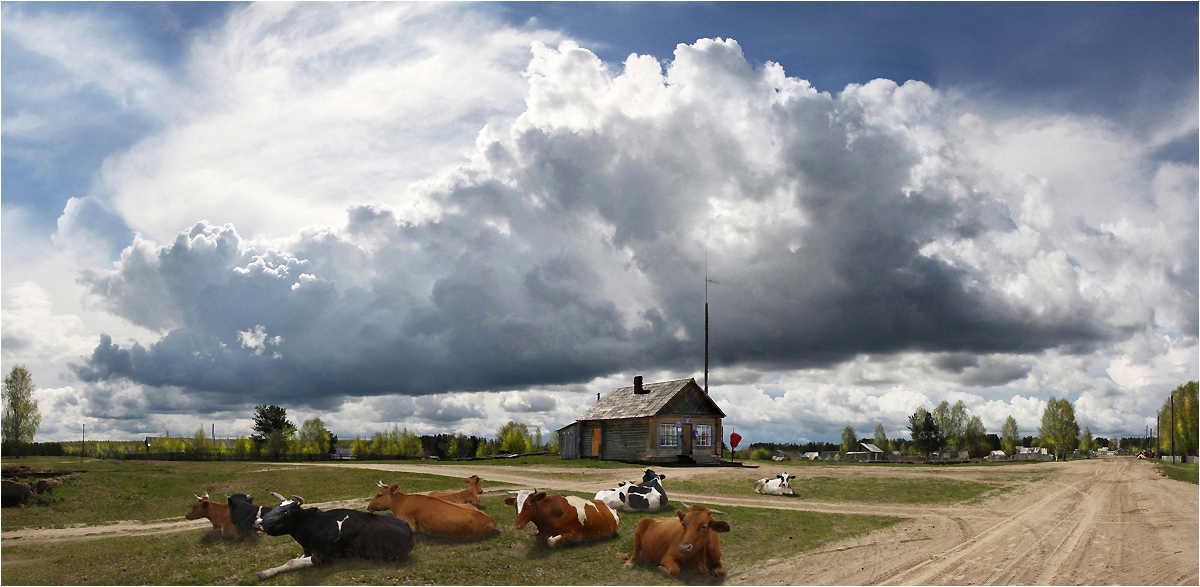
[{"x1": 0, "y1": 457, "x2": 511, "y2": 529}]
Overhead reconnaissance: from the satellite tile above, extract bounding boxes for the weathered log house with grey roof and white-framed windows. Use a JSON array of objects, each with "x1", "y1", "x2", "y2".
[{"x1": 558, "y1": 376, "x2": 725, "y2": 465}]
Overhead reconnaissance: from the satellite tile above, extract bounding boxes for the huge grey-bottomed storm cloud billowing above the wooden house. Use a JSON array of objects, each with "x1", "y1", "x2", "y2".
[{"x1": 74, "y1": 41, "x2": 1180, "y2": 412}]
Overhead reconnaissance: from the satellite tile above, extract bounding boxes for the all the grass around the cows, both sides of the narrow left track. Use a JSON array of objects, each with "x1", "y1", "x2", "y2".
[{"x1": 2, "y1": 457, "x2": 899, "y2": 585}]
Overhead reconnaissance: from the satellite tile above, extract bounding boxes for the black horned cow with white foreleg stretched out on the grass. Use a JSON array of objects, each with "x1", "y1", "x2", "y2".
[{"x1": 254, "y1": 492, "x2": 413, "y2": 579}]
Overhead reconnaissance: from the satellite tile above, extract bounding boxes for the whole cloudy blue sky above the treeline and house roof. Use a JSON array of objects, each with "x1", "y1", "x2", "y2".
[{"x1": 0, "y1": 1, "x2": 1200, "y2": 443}]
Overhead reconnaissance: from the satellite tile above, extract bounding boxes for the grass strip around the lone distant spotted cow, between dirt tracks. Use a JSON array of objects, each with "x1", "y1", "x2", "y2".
[{"x1": 667, "y1": 475, "x2": 1004, "y2": 504}]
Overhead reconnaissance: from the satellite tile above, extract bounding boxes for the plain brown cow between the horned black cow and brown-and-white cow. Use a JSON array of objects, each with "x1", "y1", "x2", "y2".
[{"x1": 367, "y1": 481, "x2": 496, "y2": 538}]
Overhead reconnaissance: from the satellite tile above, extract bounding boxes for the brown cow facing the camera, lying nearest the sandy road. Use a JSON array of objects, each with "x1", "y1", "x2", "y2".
[{"x1": 625, "y1": 502, "x2": 730, "y2": 577}]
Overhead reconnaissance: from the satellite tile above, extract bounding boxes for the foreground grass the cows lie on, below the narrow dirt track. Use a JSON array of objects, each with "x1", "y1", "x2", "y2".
[{"x1": 2, "y1": 492, "x2": 900, "y2": 585}]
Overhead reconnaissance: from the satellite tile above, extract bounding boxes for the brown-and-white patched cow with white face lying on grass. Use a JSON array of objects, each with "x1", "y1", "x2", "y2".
[{"x1": 504, "y1": 490, "x2": 620, "y2": 547}]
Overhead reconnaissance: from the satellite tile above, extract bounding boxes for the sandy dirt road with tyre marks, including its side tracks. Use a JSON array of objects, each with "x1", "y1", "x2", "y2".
[{"x1": 2, "y1": 459, "x2": 1200, "y2": 585}]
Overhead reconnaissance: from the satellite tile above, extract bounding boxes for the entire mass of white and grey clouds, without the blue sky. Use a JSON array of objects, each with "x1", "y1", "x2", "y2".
[{"x1": 4, "y1": 4, "x2": 1198, "y2": 442}]
